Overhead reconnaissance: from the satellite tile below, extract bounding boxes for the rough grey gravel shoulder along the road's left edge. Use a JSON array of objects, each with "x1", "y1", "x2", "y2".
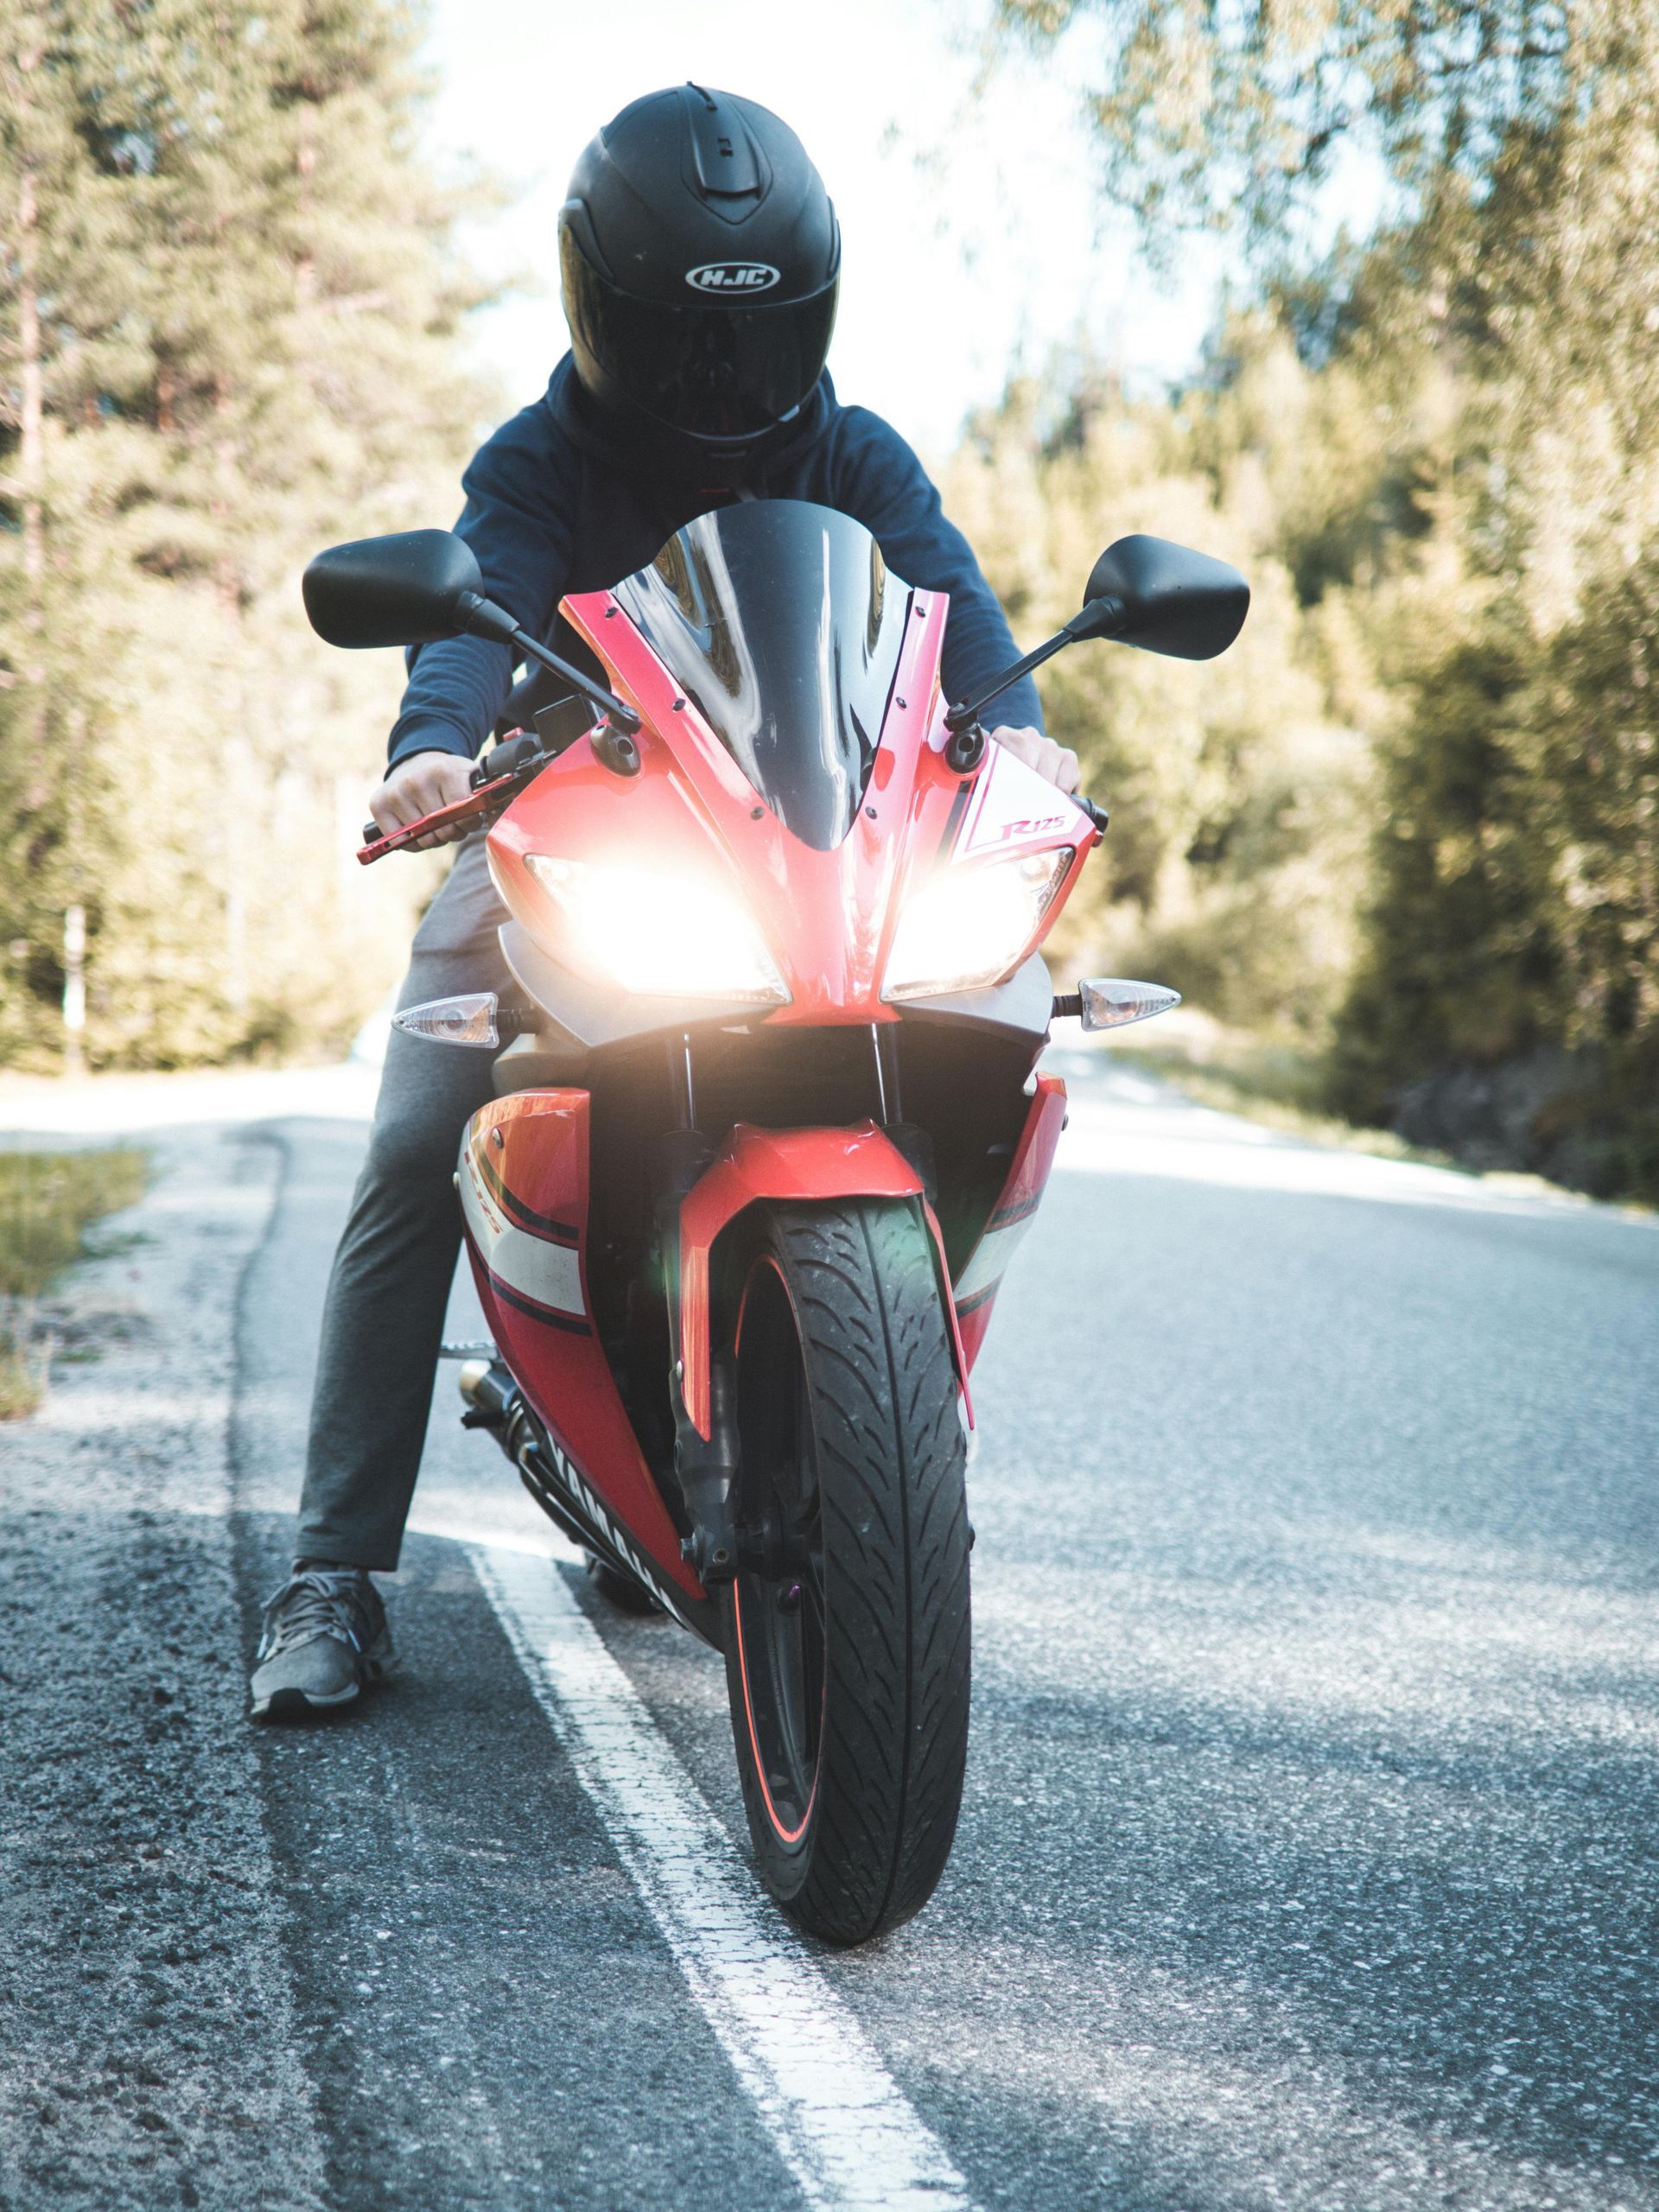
[{"x1": 0, "y1": 1128, "x2": 325, "y2": 2212}]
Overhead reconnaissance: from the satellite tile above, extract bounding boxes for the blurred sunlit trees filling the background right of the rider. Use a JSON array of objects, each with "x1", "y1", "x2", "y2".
[{"x1": 982, "y1": 0, "x2": 1659, "y2": 1197}]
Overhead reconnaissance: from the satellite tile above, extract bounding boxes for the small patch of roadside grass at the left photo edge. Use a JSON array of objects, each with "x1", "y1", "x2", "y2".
[{"x1": 0, "y1": 1148, "x2": 150, "y2": 1421}]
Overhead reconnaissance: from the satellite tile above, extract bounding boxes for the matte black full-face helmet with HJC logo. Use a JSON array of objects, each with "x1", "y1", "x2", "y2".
[{"x1": 560, "y1": 84, "x2": 841, "y2": 460}]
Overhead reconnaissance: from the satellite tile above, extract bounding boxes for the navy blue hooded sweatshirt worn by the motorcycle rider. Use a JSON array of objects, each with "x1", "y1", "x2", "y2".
[{"x1": 387, "y1": 354, "x2": 1042, "y2": 761}]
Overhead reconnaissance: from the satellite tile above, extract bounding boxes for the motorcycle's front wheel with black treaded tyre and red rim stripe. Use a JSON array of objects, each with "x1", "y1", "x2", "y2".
[{"x1": 726, "y1": 1199, "x2": 969, "y2": 1944}]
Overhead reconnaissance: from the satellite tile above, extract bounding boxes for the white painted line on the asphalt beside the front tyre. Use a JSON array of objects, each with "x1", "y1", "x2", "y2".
[{"x1": 471, "y1": 1544, "x2": 971, "y2": 2212}]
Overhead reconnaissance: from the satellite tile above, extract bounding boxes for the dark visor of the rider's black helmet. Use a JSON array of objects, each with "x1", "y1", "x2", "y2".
[{"x1": 560, "y1": 228, "x2": 836, "y2": 438}]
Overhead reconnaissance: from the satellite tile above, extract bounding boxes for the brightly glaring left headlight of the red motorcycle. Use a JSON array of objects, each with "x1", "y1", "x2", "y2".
[{"x1": 524, "y1": 852, "x2": 790, "y2": 1007}]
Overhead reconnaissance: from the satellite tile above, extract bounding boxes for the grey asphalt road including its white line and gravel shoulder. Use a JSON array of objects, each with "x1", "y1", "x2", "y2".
[{"x1": 0, "y1": 1073, "x2": 1659, "y2": 2212}]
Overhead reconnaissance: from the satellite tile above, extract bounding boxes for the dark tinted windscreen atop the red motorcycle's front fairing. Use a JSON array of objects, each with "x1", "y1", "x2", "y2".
[{"x1": 615, "y1": 500, "x2": 909, "y2": 852}]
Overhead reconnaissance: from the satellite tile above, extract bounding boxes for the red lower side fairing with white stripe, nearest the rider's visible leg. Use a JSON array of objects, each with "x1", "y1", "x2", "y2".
[{"x1": 460, "y1": 1090, "x2": 703, "y2": 1597}]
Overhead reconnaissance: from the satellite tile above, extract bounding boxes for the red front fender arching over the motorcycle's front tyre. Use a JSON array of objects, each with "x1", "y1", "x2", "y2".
[{"x1": 679, "y1": 1122, "x2": 967, "y2": 1435}]
